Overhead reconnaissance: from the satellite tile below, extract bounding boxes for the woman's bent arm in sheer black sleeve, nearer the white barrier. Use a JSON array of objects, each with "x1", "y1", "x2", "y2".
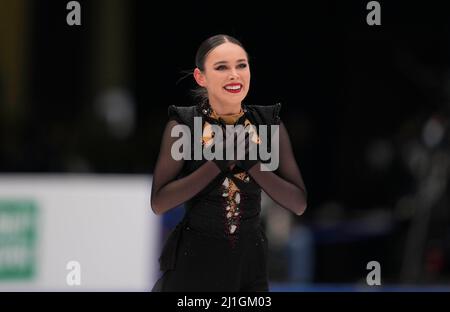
[{"x1": 150, "y1": 120, "x2": 221, "y2": 215}]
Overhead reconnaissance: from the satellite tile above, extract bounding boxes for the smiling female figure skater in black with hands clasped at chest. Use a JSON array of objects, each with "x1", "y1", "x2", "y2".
[{"x1": 151, "y1": 35, "x2": 307, "y2": 291}]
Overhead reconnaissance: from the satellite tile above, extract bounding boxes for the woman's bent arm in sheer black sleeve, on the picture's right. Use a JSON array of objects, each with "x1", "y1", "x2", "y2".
[{"x1": 248, "y1": 122, "x2": 307, "y2": 216}]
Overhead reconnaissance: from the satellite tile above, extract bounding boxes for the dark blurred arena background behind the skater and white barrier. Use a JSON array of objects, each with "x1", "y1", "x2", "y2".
[{"x1": 0, "y1": 0, "x2": 450, "y2": 284}]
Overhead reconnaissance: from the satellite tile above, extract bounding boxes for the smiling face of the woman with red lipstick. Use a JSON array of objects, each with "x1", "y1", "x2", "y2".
[{"x1": 195, "y1": 42, "x2": 250, "y2": 105}]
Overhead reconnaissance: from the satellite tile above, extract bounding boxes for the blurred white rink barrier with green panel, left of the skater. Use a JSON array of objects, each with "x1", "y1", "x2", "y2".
[{"x1": 0, "y1": 174, "x2": 160, "y2": 291}]
